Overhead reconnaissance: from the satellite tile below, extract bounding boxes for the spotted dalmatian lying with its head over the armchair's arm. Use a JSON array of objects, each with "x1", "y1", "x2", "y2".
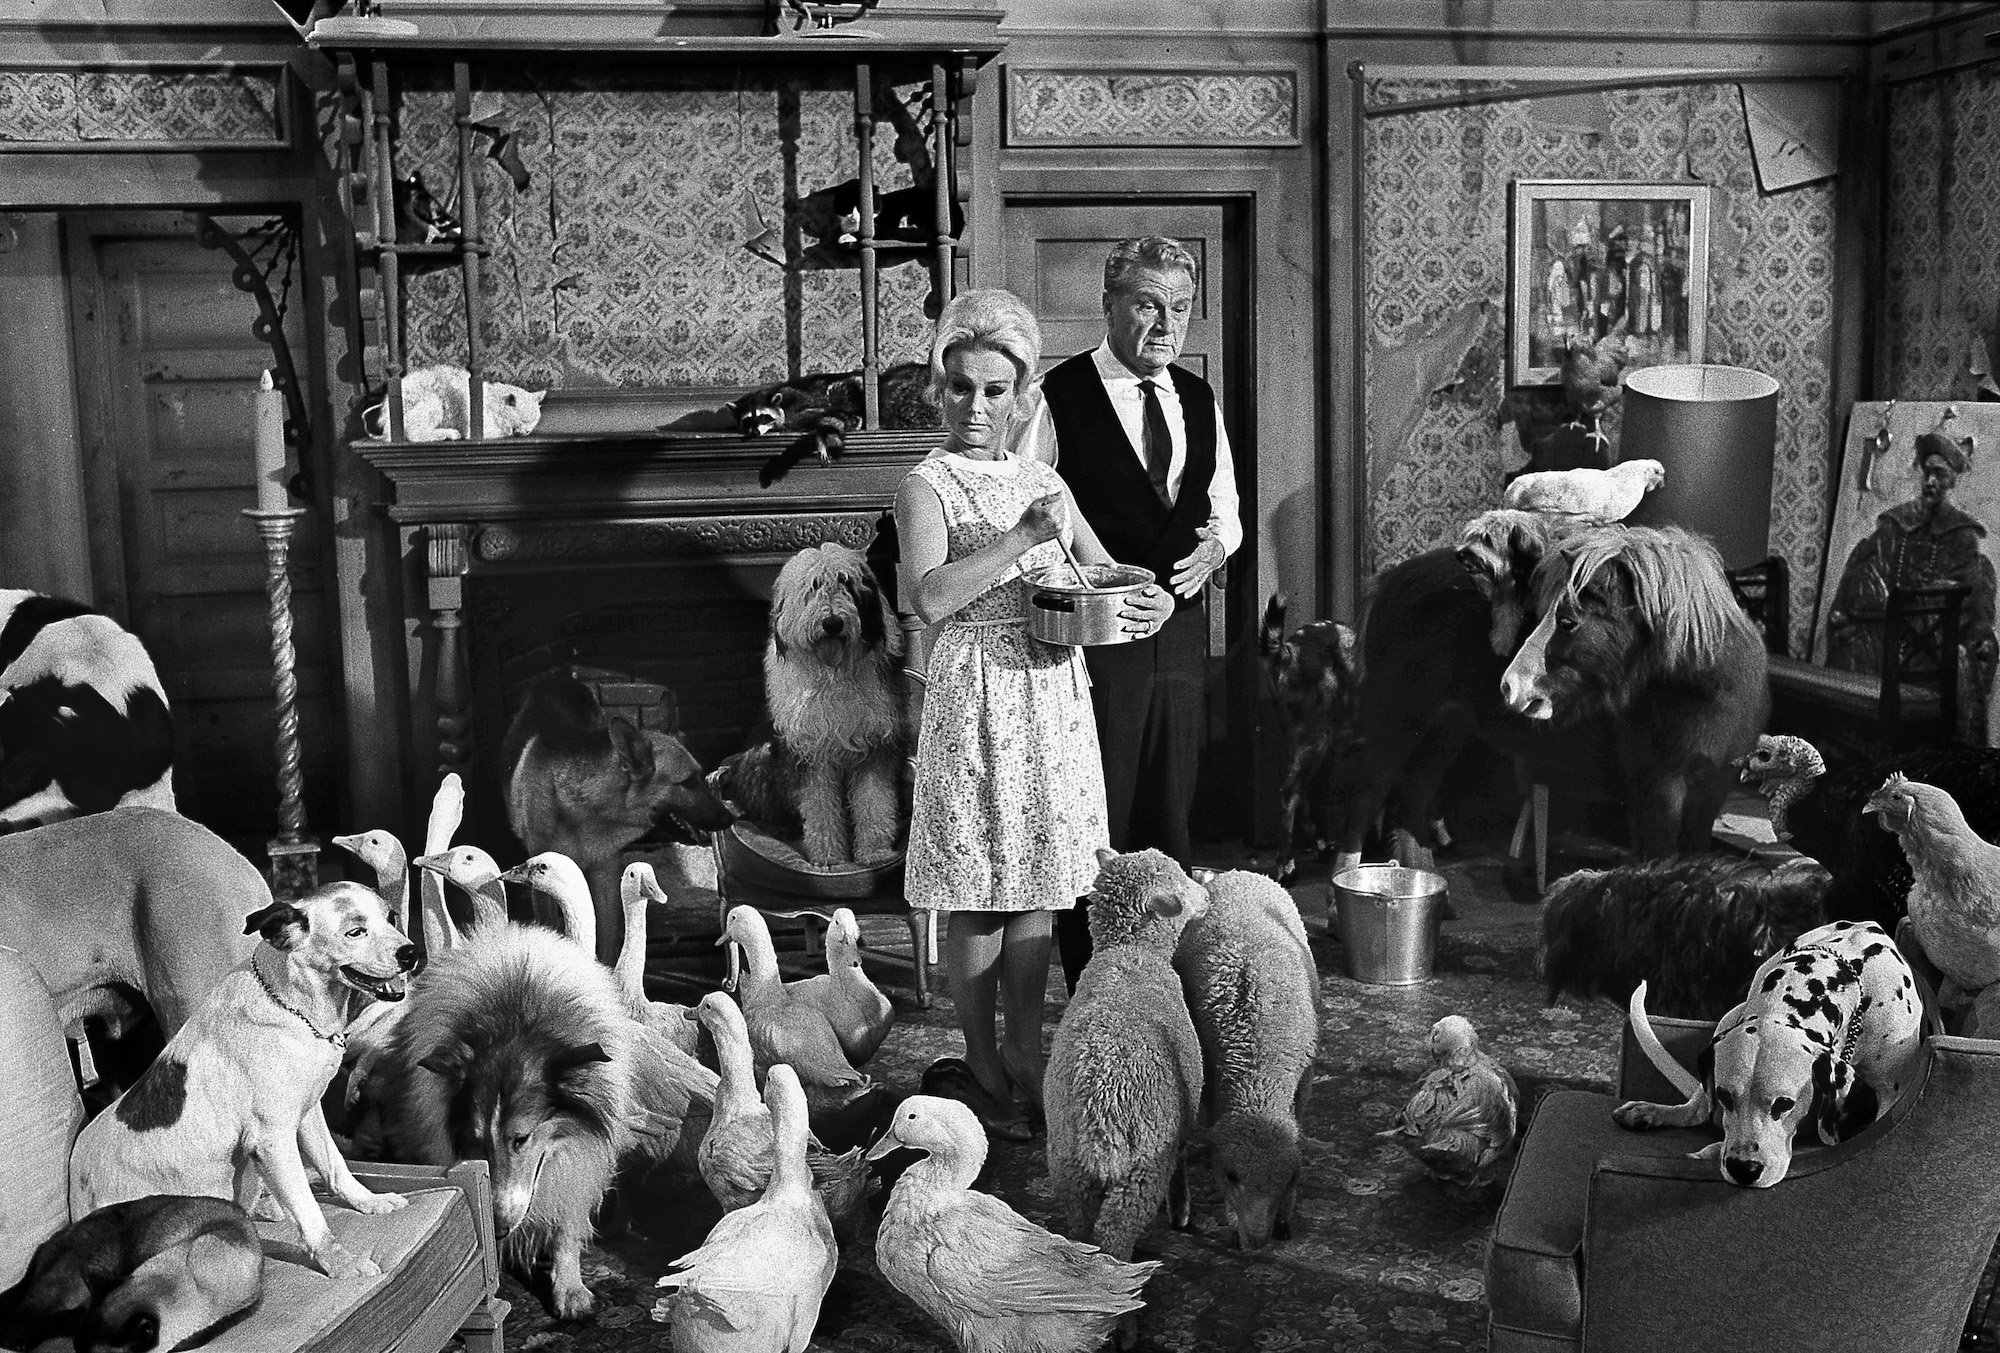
[{"x1": 1612, "y1": 921, "x2": 1924, "y2": 1189}]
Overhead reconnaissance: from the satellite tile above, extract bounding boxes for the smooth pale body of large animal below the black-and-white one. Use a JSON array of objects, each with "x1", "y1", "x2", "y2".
[{"x1": 0, "y1": 809, "x2": 270, "y2": 1037}]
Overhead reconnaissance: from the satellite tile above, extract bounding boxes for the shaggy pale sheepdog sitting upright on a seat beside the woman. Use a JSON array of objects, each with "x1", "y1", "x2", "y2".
[{"x1": 730, "y1": 544, "x2": 908, "y2": 865}]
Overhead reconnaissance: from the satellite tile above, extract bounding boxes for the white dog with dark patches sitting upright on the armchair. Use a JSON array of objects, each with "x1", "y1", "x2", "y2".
[{"x1": 70, "y1": 883, "x2": 416, "y2": 1277}]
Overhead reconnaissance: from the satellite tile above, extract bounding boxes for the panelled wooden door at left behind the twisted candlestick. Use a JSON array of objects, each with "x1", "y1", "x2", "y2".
[{"x1": 66, "y1": 212, "x2": 346, "y2": 840}]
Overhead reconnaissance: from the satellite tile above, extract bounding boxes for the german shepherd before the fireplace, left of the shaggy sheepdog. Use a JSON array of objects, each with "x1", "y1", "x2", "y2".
[{"x1": 500, "y1": 668, "x2": 734, "y2": 963}]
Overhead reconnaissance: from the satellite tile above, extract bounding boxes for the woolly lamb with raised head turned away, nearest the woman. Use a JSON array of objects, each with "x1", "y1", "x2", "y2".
[{"x1": 1042, "y1": 851, "x2": 1208, "y2": 1349}]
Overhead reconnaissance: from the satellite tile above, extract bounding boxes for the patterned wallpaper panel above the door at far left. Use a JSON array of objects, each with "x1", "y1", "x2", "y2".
[{"x1": 0, "y1": 66, "x2": 284, "y2": 146}]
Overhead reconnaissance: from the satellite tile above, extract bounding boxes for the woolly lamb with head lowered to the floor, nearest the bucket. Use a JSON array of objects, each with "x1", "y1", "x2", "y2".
[{"x1": 1174, "y1": 871, "x2": 1320, "y2": 1249}]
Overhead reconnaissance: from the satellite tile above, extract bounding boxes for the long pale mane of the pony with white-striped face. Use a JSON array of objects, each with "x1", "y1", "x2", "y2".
[{"x1": 1536, "y1": 526, "x2": 1756, "y2": 677}]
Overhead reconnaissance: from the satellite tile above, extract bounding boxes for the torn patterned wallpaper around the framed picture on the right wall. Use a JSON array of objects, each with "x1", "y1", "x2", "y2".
[{"x1": 1364, "y1": 84, "x2": 1834, "y2": 650}]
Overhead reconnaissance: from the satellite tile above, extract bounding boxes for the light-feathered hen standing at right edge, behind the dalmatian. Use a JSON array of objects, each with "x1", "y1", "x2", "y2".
[{"x1": 1864, "y1": 775, "x2": 2000, "y2": 1009}]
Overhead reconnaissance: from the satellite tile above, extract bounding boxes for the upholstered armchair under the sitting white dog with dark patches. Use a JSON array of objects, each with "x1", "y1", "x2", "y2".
[{"x1": 0, "y1": 947, "x2": 508, "y2": 1353}]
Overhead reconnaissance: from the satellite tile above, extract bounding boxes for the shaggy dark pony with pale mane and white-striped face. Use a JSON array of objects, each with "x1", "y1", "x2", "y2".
[{"x1": 1500, "y1": 526, "x2": 1770, "y2": 859}]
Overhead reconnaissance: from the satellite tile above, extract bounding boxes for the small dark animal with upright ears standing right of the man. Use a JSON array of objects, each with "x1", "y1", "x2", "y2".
[{"x1": 1258, "y1": 592, "x2": 1360, "y2": 883}]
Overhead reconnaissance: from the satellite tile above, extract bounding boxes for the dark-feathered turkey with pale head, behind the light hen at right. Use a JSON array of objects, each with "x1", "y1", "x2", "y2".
[{"x1": 1742, "y1": 735, "x2": 2000, "y2": 935}]
